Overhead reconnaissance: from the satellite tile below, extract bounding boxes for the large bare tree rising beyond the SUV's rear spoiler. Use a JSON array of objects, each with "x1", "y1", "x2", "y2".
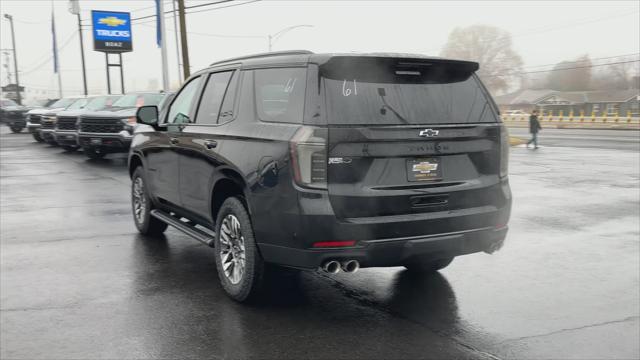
[{"x1": 441, "y1": 25, "x2": 522, "y2": 93}]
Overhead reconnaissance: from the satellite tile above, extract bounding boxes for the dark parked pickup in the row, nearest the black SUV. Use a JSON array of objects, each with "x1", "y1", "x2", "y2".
[{"x1": 78, "y1": 92, "x2": 166, "y2": 159}]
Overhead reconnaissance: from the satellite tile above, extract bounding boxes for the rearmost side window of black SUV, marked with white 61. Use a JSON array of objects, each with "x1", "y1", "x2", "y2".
[{"x1": 254, "y1": 68, "x2": 307, "y2": 124}]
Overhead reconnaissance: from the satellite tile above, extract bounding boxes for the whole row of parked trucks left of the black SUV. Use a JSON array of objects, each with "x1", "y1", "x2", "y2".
[{"x1": 3, "y1": 92, "x2": 167, "y2": 159}]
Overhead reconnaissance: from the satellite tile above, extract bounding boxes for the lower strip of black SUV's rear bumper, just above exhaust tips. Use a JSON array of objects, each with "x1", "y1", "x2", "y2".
[{"x1": 260, "y1": 227, "x2": 507, "y2": 269}]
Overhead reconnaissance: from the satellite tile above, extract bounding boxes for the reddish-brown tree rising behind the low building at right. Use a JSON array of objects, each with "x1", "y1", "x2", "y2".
[{"x1": 547, "y1": 55, "x2": 591, "y2": 91}]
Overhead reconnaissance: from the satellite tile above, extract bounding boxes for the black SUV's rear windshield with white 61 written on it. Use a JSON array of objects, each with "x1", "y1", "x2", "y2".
[{"x1": 323, "y1": 58, "x2": 498, "y2": 125}]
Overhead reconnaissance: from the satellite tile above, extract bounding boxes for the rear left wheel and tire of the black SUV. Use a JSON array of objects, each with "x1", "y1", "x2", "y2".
[{"x1": 215, "y1": 197, "x2": 265, "y2": 302}]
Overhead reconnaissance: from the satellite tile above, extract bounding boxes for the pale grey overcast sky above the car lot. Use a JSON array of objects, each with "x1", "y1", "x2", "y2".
[{"x1": 0, "y1": 0, "x2": 640, "y2": 97}]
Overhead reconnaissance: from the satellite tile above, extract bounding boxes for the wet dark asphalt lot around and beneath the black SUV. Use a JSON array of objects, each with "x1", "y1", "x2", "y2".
[{"x1": 0, "y1": 127, "x2": 640, "y2": 359}]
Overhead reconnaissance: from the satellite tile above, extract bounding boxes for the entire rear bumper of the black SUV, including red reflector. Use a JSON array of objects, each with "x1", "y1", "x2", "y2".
[{"x1": 253, "y1": 180, "x2": 511, "y2": 268}]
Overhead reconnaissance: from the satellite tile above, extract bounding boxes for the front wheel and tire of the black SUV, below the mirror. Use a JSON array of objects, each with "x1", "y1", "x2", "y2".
[{"x1": 131, "y1": 166, "x2": 168, "y2": 235}]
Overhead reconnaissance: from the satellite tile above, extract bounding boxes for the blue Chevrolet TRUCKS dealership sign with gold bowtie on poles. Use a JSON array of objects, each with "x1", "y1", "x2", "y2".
[{"x1": 91, "y1": 10, "x2": 133, "y2": 53}]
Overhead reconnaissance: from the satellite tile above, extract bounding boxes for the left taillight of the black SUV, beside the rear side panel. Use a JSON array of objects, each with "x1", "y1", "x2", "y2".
[{"x1": 290, "y1": 126, "x2": 327, "y2": 189}]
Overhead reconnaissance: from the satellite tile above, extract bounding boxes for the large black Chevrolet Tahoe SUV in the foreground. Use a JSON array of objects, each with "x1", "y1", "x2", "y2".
[{"x1": 129, "y1": 51, "x2": 511, "y2": 301}]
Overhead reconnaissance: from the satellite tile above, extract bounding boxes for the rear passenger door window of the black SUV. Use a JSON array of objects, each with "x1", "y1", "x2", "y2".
[{"x1": 196, "y1": 71, "x2": 233, "y2": 124}]
